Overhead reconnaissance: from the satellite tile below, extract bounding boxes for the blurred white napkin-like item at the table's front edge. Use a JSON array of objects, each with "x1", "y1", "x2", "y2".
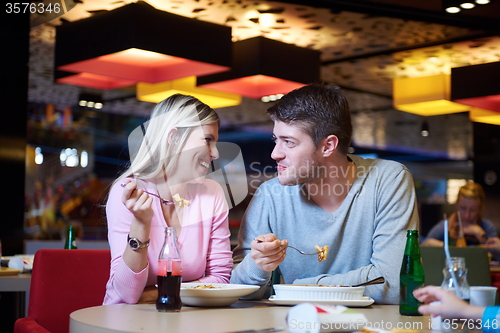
[{"x1": 287, "y1": 303, "x2": 367, "y2": 333}]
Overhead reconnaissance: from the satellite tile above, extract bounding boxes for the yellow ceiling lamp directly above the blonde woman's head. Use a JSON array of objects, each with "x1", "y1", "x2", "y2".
[{"x1": 137, "y1": 76, "x2": 241, "y2": 109}]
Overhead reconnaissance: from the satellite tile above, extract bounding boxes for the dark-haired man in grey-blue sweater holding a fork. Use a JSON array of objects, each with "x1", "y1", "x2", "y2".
[{"x1": 231, "y1": 84, "x2": 418, "y2": 304}]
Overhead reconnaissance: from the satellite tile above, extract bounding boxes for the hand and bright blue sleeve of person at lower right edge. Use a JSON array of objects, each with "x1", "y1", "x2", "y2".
[{"x1": 413, "y1": 286, "x2": 500, "y2": 332}]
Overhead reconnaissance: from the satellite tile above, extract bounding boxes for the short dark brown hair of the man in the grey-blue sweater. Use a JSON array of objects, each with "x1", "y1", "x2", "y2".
[{"x1": 267, "y1": 83, "x2": 352, "y2": 154}]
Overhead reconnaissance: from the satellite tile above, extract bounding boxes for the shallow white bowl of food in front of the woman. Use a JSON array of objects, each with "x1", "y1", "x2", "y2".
[{"x1": 181, "y1": 282, "x2": 259, "y2": 306}]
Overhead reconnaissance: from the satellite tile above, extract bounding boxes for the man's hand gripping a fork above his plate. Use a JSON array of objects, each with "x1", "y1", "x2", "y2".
[{"x1": 250, "y1": 234, "x2": 288, "y2": 272}]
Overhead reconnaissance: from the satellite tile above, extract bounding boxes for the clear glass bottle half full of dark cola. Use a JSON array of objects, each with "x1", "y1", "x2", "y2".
[{"x1": 156, "y1": 227, "x2": 182, "y2": 312}]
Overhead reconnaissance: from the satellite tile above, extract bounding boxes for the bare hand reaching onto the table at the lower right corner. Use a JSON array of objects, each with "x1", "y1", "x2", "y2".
[{"x1": 413, "y1": 286, "x2": 484, "y2": 319}]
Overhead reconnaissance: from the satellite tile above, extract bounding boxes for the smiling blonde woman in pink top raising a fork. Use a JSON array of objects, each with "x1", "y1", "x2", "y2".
[{"x1": 104, "y1": 94, "x2": 232, "y2": 304}]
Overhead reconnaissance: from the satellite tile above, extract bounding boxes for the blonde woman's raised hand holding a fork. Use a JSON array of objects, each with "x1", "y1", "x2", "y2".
[{"x1": 122, "y1": 181, "x2": 153, "y2": 224}]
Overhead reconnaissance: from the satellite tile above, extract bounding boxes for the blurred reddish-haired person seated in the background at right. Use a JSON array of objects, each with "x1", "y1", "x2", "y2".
[{"x1": 422, "y1": 182, "x2": 497, "y2": 246}]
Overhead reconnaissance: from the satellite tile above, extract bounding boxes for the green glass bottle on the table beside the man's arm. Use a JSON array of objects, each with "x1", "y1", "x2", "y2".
[{"x1": 399, "y1": 230, "x2": 425, "y2": 316}]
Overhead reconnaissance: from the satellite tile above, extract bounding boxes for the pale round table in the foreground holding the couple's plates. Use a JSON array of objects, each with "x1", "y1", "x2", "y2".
[{"x1": 70, "y1": 301, "x2": 438, "y2": 333}]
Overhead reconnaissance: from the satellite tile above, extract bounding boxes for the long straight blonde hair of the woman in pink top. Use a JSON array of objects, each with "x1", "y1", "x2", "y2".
[{"x1": 115, "y1": 94, "x2": 220, "y2": 183}]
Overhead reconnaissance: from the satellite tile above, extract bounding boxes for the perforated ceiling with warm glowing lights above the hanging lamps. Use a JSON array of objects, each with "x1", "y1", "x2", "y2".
[{"x1": 42, "y1": 0, "x2": 500, "y2": 96}]
